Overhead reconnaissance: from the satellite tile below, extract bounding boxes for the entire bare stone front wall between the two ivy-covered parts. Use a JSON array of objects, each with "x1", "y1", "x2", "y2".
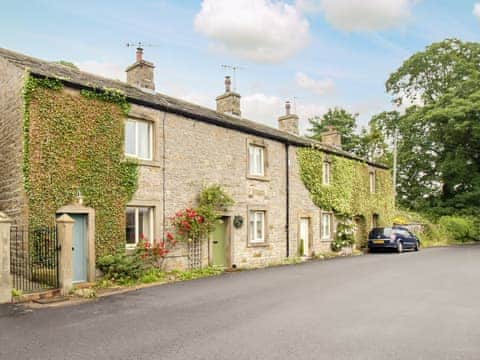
[{"x1": 130, "y1": 101, "x2": 333, "y2": 268}]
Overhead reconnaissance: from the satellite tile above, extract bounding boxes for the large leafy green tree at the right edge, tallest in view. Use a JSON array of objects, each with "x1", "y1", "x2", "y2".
[{"x1": 382, "y1": 39, "x2": 480, "y2": 214}]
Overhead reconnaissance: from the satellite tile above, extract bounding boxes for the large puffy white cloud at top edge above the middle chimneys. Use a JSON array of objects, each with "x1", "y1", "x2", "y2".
[{"x1": 195, "y1": 0, "x2": 309, "y2": 63}]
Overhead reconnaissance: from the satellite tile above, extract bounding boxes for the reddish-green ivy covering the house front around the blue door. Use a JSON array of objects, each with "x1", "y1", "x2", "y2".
[{"x1": 23, "y1": 76, "x2": 138, "y2": 257}]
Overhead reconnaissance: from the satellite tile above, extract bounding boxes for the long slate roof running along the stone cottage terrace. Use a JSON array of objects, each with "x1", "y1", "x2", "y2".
[{"x1": 0, "y1": 48, "x2": 387, "y2": 168}]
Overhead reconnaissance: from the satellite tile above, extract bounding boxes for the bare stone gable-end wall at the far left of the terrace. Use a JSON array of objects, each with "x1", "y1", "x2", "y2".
[{"x1": 0, "y1": 58, "x2": 27, "y2": 225}]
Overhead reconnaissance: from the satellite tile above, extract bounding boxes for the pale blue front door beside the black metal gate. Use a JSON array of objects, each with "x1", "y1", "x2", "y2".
[{"x1": 70, "y1": 214, "x2": 87, "y2": 283}]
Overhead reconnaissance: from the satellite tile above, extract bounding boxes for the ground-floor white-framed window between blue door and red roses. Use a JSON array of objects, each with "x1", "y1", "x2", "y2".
[{"x1": 125, "y1": 206, "x2": 153, "y2": 248}]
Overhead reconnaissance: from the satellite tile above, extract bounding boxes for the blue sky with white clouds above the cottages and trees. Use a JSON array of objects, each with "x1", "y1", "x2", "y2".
[{"x1": 0, "y1": 0, "x2": 480, "y2": 133}]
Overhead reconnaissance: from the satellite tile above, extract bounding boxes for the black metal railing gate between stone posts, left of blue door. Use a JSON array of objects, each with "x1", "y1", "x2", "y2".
[{"x1": 10, "y1": 226, "x2": 59, "y2": 293}]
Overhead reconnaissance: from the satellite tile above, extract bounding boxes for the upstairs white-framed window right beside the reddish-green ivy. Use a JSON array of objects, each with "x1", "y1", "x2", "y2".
[{"x1": 125, "y1": 119, "x2": 152, "y2": 160}]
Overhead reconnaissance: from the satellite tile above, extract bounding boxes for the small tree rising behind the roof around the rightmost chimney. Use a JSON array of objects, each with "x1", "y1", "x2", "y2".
[{"x1": 308, "y1": 107, "x2": 359, "y2": 151}]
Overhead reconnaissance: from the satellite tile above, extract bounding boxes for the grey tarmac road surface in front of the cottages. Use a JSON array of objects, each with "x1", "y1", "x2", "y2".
[{"x1": 0, "y1": 246, "x2": 480, "y2": 360}]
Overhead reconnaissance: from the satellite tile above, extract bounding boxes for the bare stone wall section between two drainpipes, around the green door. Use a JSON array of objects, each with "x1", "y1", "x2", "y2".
[{"x1": 165, "y1": 114, "x2": 286, "y2": 267}]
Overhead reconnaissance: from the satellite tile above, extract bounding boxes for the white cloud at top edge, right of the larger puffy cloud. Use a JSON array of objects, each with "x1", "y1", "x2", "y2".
[{"x1": 296, "y1": 0, "x2": 418, "y2": 31}]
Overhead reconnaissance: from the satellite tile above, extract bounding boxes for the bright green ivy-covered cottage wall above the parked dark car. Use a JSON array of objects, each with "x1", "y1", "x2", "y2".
[{"x1": 297, "y1": 148, "x2": 394, "y2": 239}]
